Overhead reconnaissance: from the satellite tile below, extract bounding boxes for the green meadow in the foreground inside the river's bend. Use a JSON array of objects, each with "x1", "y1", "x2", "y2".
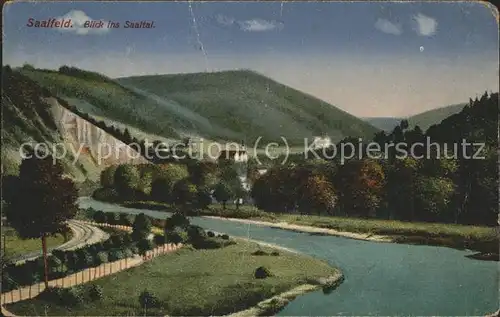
[{"x1": 7, "y1": 240, "x2": 338, "y2": 316}]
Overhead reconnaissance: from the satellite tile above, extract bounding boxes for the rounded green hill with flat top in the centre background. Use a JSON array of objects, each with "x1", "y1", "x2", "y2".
[{"x1": 117, "y1": 71, "x2": 377, "y2": 145}]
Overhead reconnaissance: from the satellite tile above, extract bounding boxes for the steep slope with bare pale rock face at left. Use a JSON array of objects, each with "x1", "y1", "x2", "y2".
[{"x1": 2, "y1": 67, "x2": 146, "y2": 181}]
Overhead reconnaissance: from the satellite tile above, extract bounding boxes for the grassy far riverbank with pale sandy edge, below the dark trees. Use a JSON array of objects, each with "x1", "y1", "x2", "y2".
[{"x1": 121, "y1": 201, "x2": 499, "y2": 261}]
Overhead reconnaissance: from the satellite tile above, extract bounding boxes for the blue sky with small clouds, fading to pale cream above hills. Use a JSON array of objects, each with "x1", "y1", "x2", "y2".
[{"x1": 3, "y1": 1, "x2": 499, "y2": 117}]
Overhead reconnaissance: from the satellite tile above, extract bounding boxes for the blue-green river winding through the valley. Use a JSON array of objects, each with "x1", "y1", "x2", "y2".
[{"x1": 80, "y1": 197, "x2": 499, "y2": 316}]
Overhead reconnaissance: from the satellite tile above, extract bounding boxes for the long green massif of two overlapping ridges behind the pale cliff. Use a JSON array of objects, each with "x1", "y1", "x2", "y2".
[{"x1": 21, "y1": 67, "x2": 378, "y2": 146}]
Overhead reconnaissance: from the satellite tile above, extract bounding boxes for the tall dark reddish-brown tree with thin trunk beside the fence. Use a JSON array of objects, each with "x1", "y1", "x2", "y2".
[{"x1": 6, "y1": 155, "x2": 78, "y2": 287}]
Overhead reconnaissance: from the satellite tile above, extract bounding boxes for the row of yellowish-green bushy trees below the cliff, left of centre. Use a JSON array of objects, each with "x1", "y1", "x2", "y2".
[{"x1": 94, "y1": 161, "x2": 247, "y2": 208}]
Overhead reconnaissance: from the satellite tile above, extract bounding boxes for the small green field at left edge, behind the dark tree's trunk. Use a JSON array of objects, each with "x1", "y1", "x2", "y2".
[{"x1": 2, "y1": 226, "x2": 65, "y2": 258}]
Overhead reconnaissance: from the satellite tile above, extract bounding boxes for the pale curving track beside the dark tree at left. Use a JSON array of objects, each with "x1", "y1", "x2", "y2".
[{"x1": 9, "y1": 220, "x2": 109, "y2": 263}]
